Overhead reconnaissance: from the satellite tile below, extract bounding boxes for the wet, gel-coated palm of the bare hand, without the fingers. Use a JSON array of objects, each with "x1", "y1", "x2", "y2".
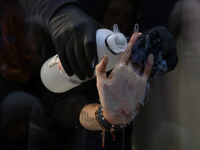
[{"x1": 99, "y1": 61, "x2": 147, "y2": 114}]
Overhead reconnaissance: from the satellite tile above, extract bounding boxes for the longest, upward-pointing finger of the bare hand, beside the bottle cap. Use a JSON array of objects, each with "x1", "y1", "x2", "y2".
[{"x1": 118, "y1": 33, "x2": 141, "y2": 64}]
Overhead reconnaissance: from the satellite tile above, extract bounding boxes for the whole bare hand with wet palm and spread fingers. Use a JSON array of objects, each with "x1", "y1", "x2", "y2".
[{"x1": 96, "y1": 33, "x2": 153, "y2": 125}]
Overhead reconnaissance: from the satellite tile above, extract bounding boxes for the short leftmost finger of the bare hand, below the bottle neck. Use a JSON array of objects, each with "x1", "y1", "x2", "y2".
[{"x1": 95, "y1": 55, "x2": 108, "y2": 82}]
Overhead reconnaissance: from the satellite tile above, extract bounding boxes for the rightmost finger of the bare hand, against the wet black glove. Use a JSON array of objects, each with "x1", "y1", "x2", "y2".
[{"x1": 142, "y1": 54, "x2": 153, "y2": 80}]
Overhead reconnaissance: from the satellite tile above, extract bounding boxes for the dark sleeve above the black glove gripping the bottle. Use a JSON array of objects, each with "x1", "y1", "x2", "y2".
[{"x1": 18, "y1": 0, "x2": 81, "y2": 27}]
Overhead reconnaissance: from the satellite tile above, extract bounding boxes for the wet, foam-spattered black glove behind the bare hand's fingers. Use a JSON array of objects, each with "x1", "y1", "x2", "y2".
[{"x1": 131, "y1": 26, "x2": 178, "y2": 75}]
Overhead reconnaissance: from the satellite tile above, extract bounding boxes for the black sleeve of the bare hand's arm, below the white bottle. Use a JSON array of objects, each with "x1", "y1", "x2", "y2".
[{"x1": 43, "y1": 90, "x2": 91, "y2": 128}]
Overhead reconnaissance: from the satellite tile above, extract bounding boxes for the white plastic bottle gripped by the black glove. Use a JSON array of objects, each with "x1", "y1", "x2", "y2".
[{"x1": 40, "y1": 25, "x2": 127, "y2": 93}]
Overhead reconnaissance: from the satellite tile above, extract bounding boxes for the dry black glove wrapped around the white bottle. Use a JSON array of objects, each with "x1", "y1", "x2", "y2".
[{"x1": 49, "y1": 5, "x2": 103, "y2": 80}]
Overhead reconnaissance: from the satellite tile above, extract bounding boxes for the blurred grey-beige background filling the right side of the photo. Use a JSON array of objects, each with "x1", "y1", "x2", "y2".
[{"x1": 133, "y1": 0, "x2": 200, "y2": 150}]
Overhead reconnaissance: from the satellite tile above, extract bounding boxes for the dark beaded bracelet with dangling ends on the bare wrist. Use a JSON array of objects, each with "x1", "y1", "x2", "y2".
[{"x1": 95, "y1": 106, "x2": 130, "y2": 148}]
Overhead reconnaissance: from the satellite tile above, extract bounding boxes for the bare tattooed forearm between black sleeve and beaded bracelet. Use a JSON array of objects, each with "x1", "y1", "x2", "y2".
[{"x1": 79, "y1": 104, "x2": 102, "y2": 131}]
